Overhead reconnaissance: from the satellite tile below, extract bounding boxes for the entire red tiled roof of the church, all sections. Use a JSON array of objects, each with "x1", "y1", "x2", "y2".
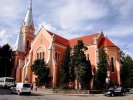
[{"x1": 42, "y1": 27, "x2": 117, "y2": 47}]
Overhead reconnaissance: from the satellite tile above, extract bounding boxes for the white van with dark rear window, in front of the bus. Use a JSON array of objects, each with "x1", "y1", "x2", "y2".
[{"x1": 10, "y1": 83, "x2": 31, "y2": 95}]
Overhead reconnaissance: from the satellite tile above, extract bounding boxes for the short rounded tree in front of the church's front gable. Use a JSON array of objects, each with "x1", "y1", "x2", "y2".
[{"x1": 31, "y1": 59, "x2": 50, "y2": 86}]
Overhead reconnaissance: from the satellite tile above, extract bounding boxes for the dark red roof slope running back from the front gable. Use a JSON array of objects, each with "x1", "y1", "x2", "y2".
[{"x1": 47, "y1": 30, "x2": 69, "y2": 46}]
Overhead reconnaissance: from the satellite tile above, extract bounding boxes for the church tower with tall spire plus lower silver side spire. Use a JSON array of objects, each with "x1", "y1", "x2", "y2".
[{"x1": 14, "y1": 0, "x2": 35, "y2": 52}]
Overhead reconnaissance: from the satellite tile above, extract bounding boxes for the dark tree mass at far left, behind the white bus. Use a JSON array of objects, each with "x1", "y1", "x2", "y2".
[{"x1": 0, "y1": 44, "x2": 13, "y2": 77}]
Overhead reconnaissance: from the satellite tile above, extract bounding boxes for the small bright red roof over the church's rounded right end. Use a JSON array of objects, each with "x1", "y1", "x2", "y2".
[{"x1": 98, "y1": 38, "x2": 117, "y2": 47}]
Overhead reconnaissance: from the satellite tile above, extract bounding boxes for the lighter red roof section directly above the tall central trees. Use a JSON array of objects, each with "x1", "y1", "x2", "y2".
[{"x1": 69, "y1": 33, "x2": 98, "y2": 46}]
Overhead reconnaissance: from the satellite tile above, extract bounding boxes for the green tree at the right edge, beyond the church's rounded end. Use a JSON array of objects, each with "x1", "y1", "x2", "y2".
[{"x1": 121, "y1": 52, "x2": 133, "y2": 88}]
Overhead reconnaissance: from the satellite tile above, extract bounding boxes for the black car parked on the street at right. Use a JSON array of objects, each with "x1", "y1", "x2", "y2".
[{"x1": 104, "y1": 87, "x2": 125, "y2": 96}]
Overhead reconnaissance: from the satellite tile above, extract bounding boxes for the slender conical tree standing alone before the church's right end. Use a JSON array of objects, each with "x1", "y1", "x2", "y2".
[{"x1": 95, "y1": 47, "x2": 109, "y2": 88}]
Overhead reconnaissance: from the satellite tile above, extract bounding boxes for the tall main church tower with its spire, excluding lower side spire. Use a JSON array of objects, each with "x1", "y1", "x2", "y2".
[{"x1": 20, "y1": 0, "x2": 35, "y2": 51}]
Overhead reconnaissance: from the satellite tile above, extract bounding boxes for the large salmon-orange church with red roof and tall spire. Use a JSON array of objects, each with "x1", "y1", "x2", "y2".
[{"x1": 13, "y1": 1, "x2": 121, "y2": 88}]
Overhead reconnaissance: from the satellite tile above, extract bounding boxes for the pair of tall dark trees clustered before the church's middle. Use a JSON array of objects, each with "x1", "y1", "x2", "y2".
[{"x1": 60, "y1": 40, "x2": 92, "y2": 88}]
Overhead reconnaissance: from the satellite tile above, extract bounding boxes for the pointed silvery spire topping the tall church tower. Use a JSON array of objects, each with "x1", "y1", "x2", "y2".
[{"x1": 24, "y1": 0, "x2": 33, "y2": 26}]
